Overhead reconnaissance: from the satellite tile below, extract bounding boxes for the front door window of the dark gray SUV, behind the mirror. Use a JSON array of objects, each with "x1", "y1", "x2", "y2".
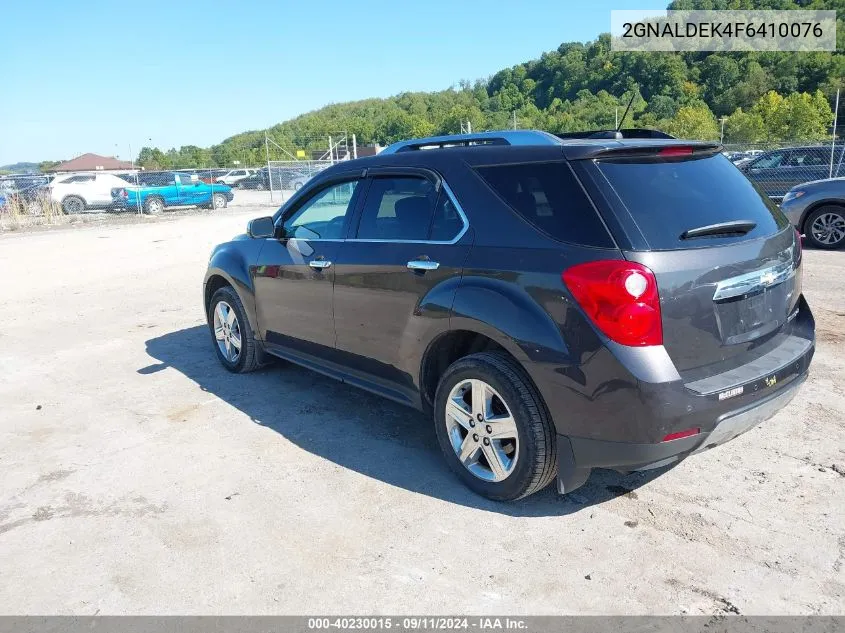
[{"x1": 284, "y1": 180, "x2": 359, "y2": 240}]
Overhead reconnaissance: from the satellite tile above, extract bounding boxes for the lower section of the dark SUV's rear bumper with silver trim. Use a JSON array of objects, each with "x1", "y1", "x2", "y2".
[{"x1": 557, "y1": 369, "x2": 807, "y2": 494}]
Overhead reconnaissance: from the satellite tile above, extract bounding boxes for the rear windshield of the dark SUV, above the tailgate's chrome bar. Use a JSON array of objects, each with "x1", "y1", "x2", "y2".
[{"x1": 595, "y1": 154, "x2": 788, "y2": 250}]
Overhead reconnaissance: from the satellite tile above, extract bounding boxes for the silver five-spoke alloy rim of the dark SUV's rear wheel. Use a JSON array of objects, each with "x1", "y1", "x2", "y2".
[{"x1": 445, "y1": 378, "x2": 519, "y2": 482}]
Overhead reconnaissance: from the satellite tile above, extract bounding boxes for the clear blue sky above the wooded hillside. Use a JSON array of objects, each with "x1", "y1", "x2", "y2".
[{"x1": 0, "y1": 0, "x2": 668, "y2": 165}]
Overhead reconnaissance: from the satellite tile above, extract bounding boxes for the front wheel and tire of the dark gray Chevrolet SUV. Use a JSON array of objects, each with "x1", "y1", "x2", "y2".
[{"x1": 208, "y1": 286, "x2": 262, "y2": 374}]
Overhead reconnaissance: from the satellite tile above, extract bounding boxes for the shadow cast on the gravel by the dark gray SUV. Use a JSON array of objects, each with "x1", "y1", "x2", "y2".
[{"x1": 138, "y1": 325, "x2": 667, "y2": 517}]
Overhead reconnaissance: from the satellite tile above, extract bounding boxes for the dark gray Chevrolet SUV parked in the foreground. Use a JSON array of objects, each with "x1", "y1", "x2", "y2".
[{"x1": 203, "y1": 130, "x2": 815, "y2": 500}]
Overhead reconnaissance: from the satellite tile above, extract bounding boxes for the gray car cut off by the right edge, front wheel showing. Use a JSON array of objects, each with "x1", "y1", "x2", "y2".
[{"x1": 781, "y1": 178, "x2": 845, "y2": 249}]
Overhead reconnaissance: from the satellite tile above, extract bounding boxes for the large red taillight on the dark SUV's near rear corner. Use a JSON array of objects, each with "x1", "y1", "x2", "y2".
[{"x1": 562, "y1": 260, "x2": 663, "y2": 347}]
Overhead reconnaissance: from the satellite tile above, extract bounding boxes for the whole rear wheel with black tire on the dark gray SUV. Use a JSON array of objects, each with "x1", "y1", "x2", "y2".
[{"x1": 434, "y1": 352, "x2": 558, "y2": 501}]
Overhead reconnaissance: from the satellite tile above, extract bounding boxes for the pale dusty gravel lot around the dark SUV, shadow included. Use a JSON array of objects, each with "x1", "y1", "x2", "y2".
[{"x1": 0, "y1": 207, "x2": 845, "y2": 614}]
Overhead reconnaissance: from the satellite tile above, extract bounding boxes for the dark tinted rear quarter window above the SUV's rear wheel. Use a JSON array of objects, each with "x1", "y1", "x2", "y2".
[{"x1": 475, "y1": 161, "x2": 613, "y2": 248}]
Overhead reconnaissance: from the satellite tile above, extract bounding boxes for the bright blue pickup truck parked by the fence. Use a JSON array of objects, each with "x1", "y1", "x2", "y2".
[{"x1": 112, "y1": 172, "x2": 235, "y2": 215}]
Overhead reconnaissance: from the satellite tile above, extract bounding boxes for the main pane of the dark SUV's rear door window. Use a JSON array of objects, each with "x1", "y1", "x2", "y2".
[{"x1": 358, "y1": 177, "x2": 438, "y2": 240}]
